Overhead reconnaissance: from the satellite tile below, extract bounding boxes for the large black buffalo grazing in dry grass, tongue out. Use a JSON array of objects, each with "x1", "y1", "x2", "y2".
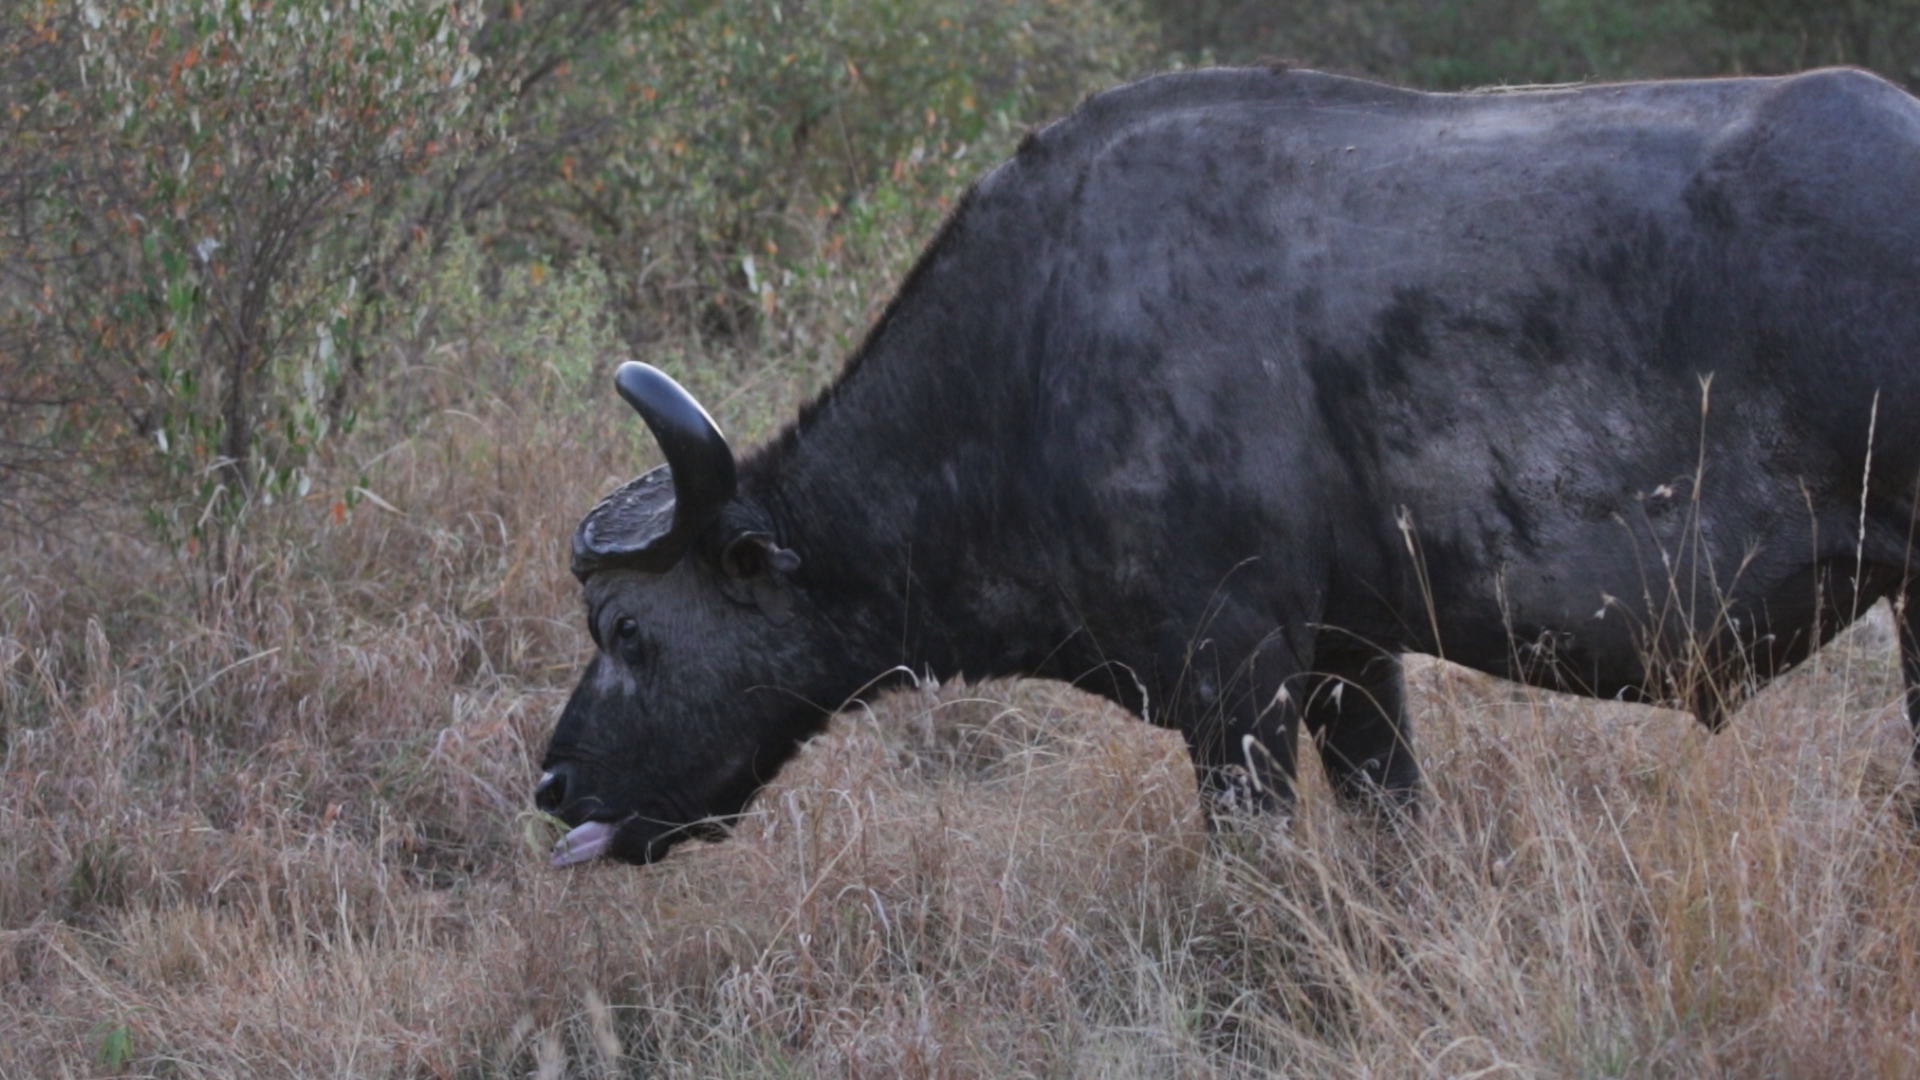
[{"x1": 538, "y1": 69, "x2": 1920, "y2": 863}]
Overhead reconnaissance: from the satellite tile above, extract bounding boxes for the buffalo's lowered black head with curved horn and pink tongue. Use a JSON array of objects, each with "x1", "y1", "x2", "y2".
[{"x1": 534, "y1": 363, "x2": 826, "y2": 865}]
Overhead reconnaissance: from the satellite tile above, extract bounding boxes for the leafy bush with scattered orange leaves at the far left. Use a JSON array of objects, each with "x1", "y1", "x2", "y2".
[{"x1": 0, "y1": 0, "x2": 478, "y2": 528}]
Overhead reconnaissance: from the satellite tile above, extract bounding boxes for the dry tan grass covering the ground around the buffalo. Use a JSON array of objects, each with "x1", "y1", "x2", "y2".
[{"x1": 0, "y1": 372, "x2": 1920, "y2": 1080}]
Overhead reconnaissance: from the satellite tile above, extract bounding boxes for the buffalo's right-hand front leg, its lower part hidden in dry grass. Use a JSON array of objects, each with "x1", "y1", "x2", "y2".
[{"x1": 1300, "y1": 650, "x2": 1421, "y2": 809}]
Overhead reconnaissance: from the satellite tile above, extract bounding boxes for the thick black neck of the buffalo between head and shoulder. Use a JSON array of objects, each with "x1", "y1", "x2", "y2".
[{"x1": 741, "y1": 182, "x2": 1071, "y2": 692}]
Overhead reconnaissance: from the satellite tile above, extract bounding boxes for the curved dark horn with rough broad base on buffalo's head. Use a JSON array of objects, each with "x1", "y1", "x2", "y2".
[{"x1": 572, "y1": 361, "x2": 737, "y2": 580}]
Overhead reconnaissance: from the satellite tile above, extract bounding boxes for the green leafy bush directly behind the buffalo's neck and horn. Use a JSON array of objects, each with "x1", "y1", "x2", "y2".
[{"x1": 486, "y1": 0, "x2": 1148, "y2": 342}]
